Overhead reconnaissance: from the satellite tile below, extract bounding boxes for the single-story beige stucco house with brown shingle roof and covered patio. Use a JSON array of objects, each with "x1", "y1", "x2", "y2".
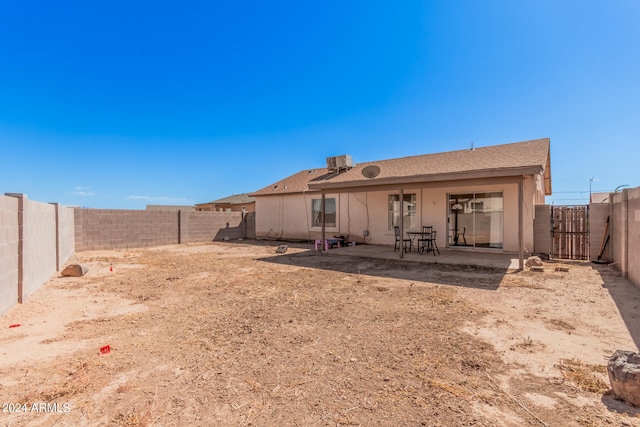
[{"x1": 252, "y1": 138, "x2": 551, "y2": 264}]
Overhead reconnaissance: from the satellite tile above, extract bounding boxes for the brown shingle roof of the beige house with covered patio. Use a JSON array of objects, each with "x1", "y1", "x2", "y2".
[{"x1": 252, "y1": 138, "x2": 551, "y2": 196}]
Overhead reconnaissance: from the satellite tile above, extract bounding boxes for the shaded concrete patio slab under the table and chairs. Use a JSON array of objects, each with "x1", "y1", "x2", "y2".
[{"x1": 320, "y1": 245, "x2": 519, "y2": 272}]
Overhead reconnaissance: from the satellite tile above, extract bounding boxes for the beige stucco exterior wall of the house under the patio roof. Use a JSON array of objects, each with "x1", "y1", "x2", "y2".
[{"x1": 256, "y1": 177, "x2": 544, "y2": 252}]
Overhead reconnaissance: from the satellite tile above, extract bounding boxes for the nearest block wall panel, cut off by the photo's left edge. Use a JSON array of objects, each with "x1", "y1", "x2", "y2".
[{"x1": 0, "y1": 196, "x2": 18, "y2": 314}]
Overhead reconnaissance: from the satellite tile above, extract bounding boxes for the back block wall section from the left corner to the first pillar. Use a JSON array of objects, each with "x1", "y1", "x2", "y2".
[{"x1": 75, "y1": 208, "x2": 179, "y2": 251}]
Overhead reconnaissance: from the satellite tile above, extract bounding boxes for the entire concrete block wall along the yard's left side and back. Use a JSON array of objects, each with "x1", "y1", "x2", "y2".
[{"x1": 0, "y1": 197, "x2": 255, "y2": 314}]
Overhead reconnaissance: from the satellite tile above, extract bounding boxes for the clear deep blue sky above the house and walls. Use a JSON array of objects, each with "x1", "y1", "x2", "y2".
[{"x1": 0, "y1": 0, "x2": 640, "y2": 209}]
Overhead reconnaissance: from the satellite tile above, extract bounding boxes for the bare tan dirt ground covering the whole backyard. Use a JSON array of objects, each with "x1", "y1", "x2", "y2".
[{"x1": 0, "y1": 242, "x2": 640, "y2": 426}]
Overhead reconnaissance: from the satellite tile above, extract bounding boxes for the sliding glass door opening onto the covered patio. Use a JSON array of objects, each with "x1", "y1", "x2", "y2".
[{"x1": 448, "y1": 192, "x2": 503, "y2": 249}]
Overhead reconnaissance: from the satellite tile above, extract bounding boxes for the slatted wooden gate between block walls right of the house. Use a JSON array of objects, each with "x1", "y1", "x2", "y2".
[{"x1": 551, "y1": 206, "x2": 589, "y2": 259}]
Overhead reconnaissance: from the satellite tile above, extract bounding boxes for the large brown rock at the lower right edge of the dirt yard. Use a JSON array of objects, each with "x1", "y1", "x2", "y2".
[{"x1": 607, "y1": 350, "x2": 640, "y2": 407}]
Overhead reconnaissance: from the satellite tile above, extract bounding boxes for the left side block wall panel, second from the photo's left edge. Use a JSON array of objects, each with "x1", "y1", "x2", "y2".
[{"x1": 20, "y1": 197, "x2": 57, "y2": 302}]
